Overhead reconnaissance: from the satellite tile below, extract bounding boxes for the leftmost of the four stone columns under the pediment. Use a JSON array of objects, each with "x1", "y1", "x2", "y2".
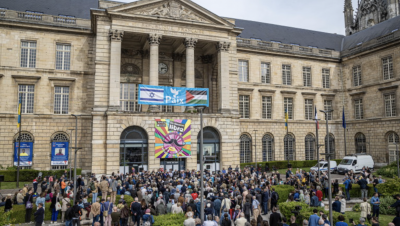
[{"x1": 108, "y1": 29, "x2": 124, "y2": 111}]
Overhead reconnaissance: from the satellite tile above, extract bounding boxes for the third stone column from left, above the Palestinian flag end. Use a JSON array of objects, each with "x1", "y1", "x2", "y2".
[{"x1": 184, "y1": 38, "x2": 197, "y2": 112}]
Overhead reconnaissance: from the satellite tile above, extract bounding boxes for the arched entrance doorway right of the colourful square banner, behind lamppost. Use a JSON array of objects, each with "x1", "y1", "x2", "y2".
[{"x1": 197, "y1": 127, "x2": 221, "y2": 172}]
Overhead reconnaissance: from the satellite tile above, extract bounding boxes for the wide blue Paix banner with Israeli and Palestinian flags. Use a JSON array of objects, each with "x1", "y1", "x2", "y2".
[{"x1": 138, "y1": 84, "x2": 209, "y2": 107}]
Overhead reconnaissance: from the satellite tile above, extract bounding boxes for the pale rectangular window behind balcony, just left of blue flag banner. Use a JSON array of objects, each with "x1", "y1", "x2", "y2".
[{"x1": 120, "y1": 83, "x2": 141, "y2": 112}]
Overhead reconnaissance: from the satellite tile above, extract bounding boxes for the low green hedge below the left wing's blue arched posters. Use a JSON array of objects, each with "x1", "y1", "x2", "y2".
[{"x1": 0, "y1": 169, "x2": 82, "y2": 182}]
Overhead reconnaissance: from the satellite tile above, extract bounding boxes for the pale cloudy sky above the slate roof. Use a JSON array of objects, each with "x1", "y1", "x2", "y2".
[{"x1": 118, "y1": 0, "x2": 358, "y2": 34}]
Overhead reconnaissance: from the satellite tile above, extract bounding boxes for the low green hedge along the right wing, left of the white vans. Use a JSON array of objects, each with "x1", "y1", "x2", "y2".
[{"x1": 240, "y1": 159, "x2": 342, "y2": 170}]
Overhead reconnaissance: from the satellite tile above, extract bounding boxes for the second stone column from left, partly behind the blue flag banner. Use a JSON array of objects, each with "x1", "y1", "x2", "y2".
[{"x1": 149, "y1": 34, "x2": 162, "y2": 112}]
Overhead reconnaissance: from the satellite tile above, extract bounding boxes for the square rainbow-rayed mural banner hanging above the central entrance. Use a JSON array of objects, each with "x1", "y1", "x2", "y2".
[{"x1": 155, "y1": 119, "x2": 192, "y2": 159}]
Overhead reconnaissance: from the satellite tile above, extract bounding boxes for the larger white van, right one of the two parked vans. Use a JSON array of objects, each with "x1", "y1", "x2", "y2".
[{"x1": 338, "y1": 154, "x2": 375, "y2": 174}]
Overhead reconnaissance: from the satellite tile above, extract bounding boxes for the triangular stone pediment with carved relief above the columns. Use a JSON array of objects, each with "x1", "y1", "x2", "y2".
[{"x1": 107, "y1": 0, "x2": 234, "y2": 28}]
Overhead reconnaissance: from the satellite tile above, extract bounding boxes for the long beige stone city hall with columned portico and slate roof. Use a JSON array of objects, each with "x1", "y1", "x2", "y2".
[{"x1": 0, "y1": 0, "x2": 400, "y2": 174}]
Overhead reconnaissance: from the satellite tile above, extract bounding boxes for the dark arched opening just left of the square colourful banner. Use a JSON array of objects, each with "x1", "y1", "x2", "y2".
[{"x1": 120, "y1": 126, "x2": 148, "y2": 173}]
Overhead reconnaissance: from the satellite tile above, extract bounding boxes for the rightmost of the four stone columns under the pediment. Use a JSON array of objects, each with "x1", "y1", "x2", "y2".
[{"x1": 217, "y1": 42, "x2": 231, "y2": 114}]
